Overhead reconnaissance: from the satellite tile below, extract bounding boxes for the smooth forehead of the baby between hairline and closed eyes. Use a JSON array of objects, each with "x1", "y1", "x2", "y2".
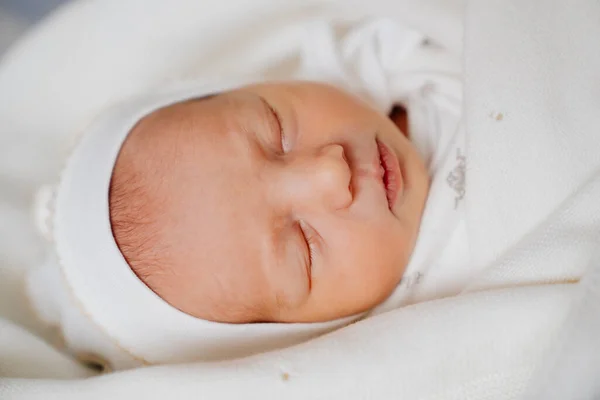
[{"x1": 138, "y1": 92, "x2": 272, "y2": 318}]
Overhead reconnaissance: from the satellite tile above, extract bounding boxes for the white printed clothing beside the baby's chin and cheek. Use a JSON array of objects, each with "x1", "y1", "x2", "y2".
[{"x1": 374, "y1": 78, "x2": 468, "y2": 314}]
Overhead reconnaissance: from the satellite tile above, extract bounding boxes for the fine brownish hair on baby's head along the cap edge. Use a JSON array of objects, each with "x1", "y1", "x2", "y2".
[{"x1": 109, "y1": 94, "x2": 215, "y2": 288}]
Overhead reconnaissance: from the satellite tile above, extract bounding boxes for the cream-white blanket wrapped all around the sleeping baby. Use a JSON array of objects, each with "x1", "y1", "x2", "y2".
[{"x1": 0, "y1": 0, "x2": 600, "y2": 399}]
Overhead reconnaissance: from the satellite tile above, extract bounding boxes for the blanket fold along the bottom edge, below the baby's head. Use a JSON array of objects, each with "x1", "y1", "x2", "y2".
[{"x1": 0, "y1": 287, "x2": 573, "y2": 400}]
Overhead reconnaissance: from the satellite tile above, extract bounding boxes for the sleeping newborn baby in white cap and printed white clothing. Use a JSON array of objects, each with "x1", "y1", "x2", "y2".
[{"x1": 28, "y1": 72, "x2": 467, "y2": 370}]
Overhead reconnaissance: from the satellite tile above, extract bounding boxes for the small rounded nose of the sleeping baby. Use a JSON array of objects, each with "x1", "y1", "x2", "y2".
[{"x1": 280, "y1": 144, "x2": 352, "y2": 210}]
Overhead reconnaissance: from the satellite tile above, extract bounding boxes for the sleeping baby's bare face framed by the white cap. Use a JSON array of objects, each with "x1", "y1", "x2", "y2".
[{"x1": 111, "y1": 83, "x2": 429, "y2": 323}]
